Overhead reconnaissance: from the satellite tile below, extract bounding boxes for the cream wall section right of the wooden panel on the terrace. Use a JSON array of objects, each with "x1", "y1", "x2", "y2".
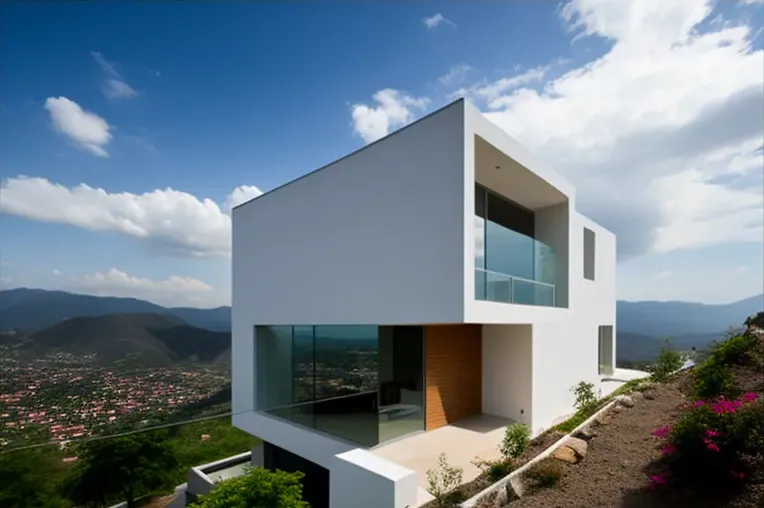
[{"x1": 482, "y1": 325, "x2": 533, "y2": 426}]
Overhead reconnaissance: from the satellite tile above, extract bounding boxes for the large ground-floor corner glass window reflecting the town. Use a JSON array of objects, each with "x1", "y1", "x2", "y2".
[{"x1": 255, "y1": 326, "x2": 425, "y2": 446}]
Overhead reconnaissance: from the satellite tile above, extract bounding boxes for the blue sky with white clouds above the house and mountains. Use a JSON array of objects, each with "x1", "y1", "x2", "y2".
[{"x1": 0, "y1": 0, "x2": 764, "y2": 306}]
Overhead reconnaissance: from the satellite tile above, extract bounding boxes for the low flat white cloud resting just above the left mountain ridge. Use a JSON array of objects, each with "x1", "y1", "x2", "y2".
[{"x1": 64, "y1": 268, "x2": 222, "y2": 307}]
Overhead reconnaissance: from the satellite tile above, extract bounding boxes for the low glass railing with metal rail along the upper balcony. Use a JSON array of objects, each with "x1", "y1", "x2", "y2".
[{"x1": 475, "y1": 268, "x2": 555, "y2": 307}]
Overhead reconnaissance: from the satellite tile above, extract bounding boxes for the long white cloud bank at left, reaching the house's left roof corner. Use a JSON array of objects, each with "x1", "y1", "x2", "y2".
[{"x1": 0, "y1": 176, "x2": 260, "y2": 258}]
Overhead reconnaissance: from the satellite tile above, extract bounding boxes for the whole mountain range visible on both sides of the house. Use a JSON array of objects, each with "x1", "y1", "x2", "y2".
[{"x1": 0, "y1": 288, "x2": 764, "y2": 363}]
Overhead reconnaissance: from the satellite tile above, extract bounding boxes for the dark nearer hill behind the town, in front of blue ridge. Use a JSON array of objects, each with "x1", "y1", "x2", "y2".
[{"x1": 24, "y1": 314, "x2": 231, "y2": 366}]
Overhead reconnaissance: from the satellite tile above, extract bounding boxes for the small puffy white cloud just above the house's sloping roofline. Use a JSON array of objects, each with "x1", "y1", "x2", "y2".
[{"x1": 351, "y1": 88, "x2": 430, "y2": 143}]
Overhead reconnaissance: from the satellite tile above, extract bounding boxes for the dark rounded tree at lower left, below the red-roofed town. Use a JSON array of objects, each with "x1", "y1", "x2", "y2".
[{"x1": 67, "y1": 431, "x2": 178, "y2": 508}]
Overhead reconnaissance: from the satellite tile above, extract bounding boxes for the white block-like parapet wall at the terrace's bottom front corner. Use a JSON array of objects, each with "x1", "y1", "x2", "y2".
[{"x1": 329, "y1": 448, "x2": 418, "y2": 508}]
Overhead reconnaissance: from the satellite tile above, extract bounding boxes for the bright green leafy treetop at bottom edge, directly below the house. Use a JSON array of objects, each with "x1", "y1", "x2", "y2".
[{"x1": 193, "y1": 467, "x2": 310, "y2": 508}]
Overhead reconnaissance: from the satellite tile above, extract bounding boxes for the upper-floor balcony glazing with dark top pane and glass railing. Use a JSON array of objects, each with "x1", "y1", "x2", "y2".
[{"x1": 475, "y1": 185, "x2": 555, "y2": 306}]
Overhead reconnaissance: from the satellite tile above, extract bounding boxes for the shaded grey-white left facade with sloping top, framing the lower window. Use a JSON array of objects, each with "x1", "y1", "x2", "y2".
[{"x1": 232, "y1": 103, "x2": 464, "y2": 496}]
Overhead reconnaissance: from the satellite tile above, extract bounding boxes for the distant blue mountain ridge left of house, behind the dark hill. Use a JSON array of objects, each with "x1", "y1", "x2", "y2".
[{"x1": 0, "y1": 288, "x2": 231, "y2": 332}]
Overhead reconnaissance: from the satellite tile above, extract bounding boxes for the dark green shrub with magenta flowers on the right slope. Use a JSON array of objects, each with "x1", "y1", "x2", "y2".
[{"x1": 653, "y1": 393, "x2": 764, "y2": 486}]
